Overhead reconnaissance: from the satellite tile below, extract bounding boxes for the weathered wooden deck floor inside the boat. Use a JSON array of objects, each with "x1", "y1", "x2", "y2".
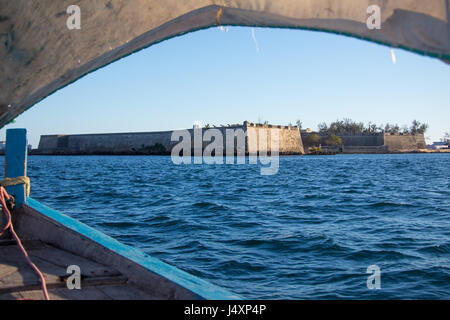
[{"x1": 0, "y1": 240, "x2": 155, "y2": 300}]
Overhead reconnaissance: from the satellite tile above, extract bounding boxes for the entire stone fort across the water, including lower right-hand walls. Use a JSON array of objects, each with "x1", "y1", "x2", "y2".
[{"x1": 35, "y1": 121, "x2": 426, "y2": 155}]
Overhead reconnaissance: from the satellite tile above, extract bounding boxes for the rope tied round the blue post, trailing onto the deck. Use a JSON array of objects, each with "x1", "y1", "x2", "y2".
[{"x1": 0, "y1": 181, "x2": 50, "y2": 300}]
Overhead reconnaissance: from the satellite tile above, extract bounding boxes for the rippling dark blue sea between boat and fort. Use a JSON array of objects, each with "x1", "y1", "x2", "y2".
[{"x1": 5, "y1": 154, "x2": 450, "y2": 299}]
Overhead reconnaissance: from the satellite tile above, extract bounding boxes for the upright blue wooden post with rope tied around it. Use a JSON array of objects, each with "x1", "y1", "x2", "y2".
[{"x1": 5, "y1": 129, "x2": 28, "y2": 208}]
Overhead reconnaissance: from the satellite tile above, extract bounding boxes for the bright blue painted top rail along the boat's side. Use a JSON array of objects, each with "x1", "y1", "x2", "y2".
[{"x1": 27, "y1": 198, "x2": 243, "y2": 300}]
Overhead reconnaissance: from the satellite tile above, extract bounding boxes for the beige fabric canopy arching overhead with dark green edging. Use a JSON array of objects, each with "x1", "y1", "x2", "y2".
[{"x1": 0, "y1": 0, "x2": 450, "y2": 127}]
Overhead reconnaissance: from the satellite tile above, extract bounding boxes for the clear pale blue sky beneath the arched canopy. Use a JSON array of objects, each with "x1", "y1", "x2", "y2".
[{"x1": 0, "y1": 27, "x2": 450, "y2": 147}]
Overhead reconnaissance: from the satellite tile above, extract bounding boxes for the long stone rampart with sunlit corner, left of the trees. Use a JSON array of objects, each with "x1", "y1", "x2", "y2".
[{"x1": 36, "y1": 121, "x2": 304, "y2": 155}]
